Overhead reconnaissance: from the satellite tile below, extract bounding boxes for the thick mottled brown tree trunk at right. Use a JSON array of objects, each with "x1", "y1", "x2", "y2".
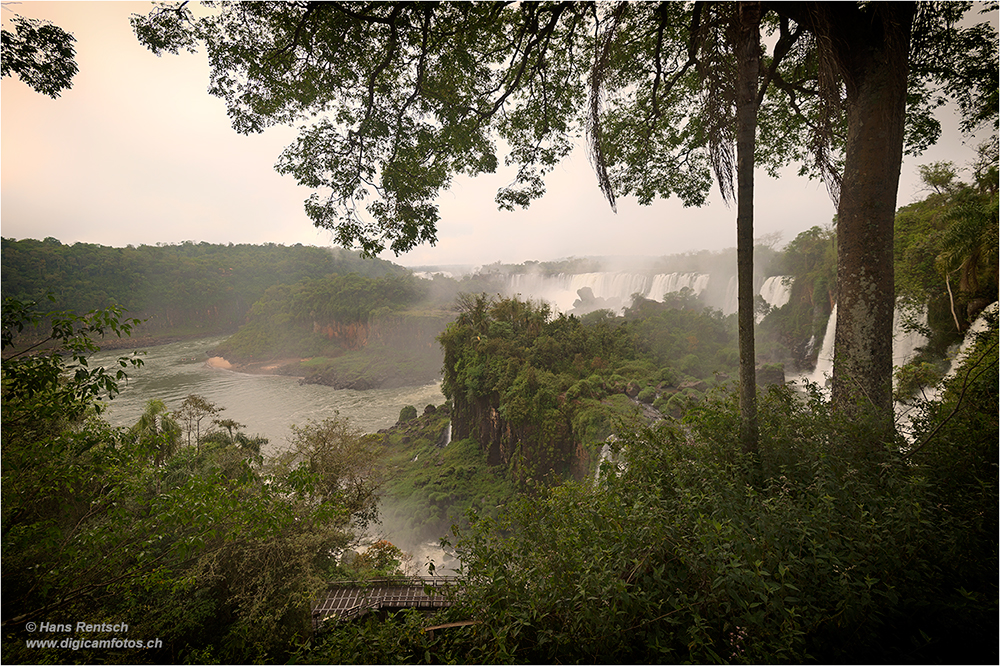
[{"x1": 829, "y1": 2, "x2": 915, "y2": 437}]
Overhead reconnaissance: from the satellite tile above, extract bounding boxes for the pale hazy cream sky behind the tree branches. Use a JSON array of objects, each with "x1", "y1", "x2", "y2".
[{"x1": 0, "y1": 2, "x2": 996, "y2": 266}]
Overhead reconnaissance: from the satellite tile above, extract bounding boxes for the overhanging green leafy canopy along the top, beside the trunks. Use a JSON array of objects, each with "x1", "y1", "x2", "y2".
[{"x1": 132, "y1": 2, "x2": 996, "y2": 246}]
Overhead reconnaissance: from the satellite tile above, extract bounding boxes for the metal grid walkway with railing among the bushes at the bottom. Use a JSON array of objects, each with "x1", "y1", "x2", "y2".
[{"x1": 312, "y1": 576, "x2": 458, "y2": 630}]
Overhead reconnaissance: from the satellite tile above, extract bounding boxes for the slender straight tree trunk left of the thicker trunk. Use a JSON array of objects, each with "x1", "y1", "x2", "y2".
[{"x1": 735, "y1": 2, "x2": 761, "y2": 451}]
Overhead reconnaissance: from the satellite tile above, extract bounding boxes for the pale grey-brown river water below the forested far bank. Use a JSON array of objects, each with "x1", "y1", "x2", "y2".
[{"x1": 91, "y1": 337, "x2": 445, "y2": 454}]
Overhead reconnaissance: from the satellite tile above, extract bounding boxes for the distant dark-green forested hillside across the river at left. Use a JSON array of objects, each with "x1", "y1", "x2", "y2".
[{"x1": 2, "y1": 238, "x2": 407, "y2": 335}]
